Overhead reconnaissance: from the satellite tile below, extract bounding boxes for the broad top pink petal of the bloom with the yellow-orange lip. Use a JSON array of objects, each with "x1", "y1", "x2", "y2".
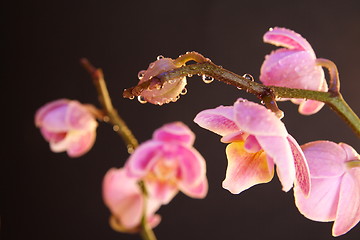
[{"x1": 234, "y1": 100, "x2": 288, "y2": 137}]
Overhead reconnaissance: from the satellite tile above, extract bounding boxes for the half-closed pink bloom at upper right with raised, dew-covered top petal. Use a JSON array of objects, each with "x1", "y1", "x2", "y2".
[{"x1": 260, "y1": 27, "x2": 328, "y2": 115}]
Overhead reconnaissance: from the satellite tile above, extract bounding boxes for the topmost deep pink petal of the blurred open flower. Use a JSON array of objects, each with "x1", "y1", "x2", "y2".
[{"x1": 153, "y1": 122, "x2": 195, "y2": 146}]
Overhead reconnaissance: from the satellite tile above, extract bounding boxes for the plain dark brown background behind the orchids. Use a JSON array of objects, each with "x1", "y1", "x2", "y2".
[{"x1": 0, "y1": 0, "x2": 360, "y2": 240}]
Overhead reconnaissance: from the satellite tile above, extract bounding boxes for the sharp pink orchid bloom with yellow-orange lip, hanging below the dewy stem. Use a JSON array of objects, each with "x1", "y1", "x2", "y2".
[{"x1": 194, "y1": 98, "x2": 310, "y2": 195}]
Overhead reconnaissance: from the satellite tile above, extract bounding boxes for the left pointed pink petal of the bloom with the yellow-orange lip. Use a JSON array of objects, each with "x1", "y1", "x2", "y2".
[{"x1": 194, "y1": 106, "x2": 239, "y2": 136}]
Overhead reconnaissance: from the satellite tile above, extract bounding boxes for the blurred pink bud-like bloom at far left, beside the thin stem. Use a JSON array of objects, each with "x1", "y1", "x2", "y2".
[{"x1": 35, "y1": 99, "x2": 97, "y2": 157}]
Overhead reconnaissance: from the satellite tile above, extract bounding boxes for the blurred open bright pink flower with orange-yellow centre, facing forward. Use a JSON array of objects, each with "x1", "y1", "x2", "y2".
[{"x1": 125, "y1": 122, "x2": 208, "y2": 204}]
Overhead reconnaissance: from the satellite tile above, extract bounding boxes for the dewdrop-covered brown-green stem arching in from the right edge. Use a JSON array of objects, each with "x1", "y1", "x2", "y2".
[{"x1": 123, "y1": 61, "x2": 360, "y2": 136}]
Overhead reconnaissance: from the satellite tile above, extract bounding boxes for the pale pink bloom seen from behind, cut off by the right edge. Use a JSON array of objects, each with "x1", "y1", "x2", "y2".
[{"x1": 294, "y1": 141, "x2": 360, "y2": 236}]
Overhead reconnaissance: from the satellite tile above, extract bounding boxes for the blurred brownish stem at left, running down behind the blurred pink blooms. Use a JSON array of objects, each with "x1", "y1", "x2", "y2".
[{"x1": 81, "y1": 58, "x2": 156, "y2": 240}]
